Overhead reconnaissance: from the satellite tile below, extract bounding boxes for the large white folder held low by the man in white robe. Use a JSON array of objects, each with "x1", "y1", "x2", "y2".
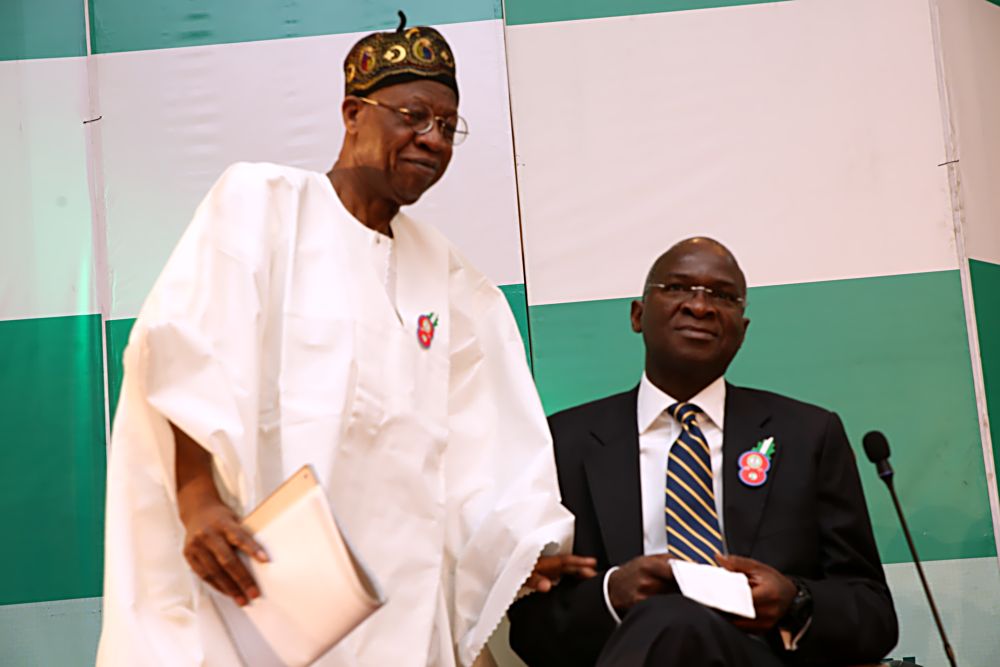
[{"x1": 217, "y1": 466, "x2": 385, "y2": 667}]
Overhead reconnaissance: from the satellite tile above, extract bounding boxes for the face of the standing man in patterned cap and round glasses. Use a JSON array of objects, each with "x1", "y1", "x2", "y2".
[{"x1": 345, "y1": 81, "x2": 458, "y2": 206}]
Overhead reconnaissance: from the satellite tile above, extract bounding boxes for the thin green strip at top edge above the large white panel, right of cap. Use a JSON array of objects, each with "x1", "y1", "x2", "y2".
[{"x1": 505, "y1": 0, "x2": 786, "y2": 26}]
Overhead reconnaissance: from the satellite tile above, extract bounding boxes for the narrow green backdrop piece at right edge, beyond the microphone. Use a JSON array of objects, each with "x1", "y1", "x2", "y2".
[{"x1": 969, "y1": 258, "x2": 1000, "y2": 472}]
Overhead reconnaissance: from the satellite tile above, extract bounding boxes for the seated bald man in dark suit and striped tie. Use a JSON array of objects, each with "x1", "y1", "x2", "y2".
[{"x1": 510, "y1": 238, "x2": 897, "y2": 667}]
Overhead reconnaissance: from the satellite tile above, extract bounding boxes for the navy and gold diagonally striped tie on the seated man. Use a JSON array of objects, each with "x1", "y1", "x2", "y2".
[{"x1": 666, "y1": 403, "x2": 722, "y2": 565}]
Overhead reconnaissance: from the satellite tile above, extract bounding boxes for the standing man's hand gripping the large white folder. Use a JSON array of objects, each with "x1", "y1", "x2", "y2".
[{"x1": 178, "y1": 501, "x2": 268, "y2": 606}]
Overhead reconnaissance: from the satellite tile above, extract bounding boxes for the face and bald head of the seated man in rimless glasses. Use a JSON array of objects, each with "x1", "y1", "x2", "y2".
[{"x1": 632, "y1": 242, "x2": 750, "y2": 377}]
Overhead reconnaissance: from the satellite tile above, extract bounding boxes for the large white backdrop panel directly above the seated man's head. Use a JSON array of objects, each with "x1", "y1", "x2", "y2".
[{"x1": 508, "y1": 0, "x2": 957, "y2": 304}]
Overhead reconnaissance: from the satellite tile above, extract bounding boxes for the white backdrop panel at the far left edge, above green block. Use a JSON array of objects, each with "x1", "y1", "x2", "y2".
[{"x1": 0, "y1": 58, "x2": 97, "y2": 319}]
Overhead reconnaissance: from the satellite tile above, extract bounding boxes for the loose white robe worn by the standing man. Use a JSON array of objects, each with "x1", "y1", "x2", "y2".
[{"x1": 98, "y1": 164, "x2": 573, "y2": 667}]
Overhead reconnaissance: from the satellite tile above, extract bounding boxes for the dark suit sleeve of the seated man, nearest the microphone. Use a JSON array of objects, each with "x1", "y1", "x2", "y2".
[{"x1": 793, "y1": 414, "x2": 898, "y2": 665}]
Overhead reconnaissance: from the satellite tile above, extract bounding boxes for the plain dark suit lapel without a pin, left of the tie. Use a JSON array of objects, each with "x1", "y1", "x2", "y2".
[{"x1": 584, "y1": 388, "x2": 643, "y2": 565}]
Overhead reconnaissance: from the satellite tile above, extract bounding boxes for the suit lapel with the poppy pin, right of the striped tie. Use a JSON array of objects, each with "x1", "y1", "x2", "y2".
[{"x1": 722, "y1": 384, "x2": 782, "y2": 556}]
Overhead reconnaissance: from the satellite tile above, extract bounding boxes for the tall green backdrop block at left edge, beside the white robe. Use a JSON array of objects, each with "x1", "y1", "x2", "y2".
[{"x1": 0, "y1": 315, "x2": 105, "y2": 604}]
